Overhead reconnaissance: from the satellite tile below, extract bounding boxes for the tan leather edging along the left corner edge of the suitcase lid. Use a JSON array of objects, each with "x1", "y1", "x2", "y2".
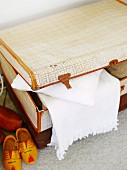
[{"x1": 0, "y1": 39, "x2": 39, "y2": 90}]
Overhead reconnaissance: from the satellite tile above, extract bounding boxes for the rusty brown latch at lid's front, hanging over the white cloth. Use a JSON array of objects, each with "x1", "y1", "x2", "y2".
[{"x1": 58, "y1": 73, "x2": 71, "y2": 89}]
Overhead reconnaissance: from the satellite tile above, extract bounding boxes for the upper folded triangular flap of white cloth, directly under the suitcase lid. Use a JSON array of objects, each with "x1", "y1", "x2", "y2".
[{"x1": 11, "y1": 70, "x2": 102, "y2": 105}]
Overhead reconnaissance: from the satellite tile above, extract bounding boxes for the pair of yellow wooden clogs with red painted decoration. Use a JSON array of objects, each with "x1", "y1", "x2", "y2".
[{"x1": 3, "y1": 128, "x2": 38, "y2": 170}]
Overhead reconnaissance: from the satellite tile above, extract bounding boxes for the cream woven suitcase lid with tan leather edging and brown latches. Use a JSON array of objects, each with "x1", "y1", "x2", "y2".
[{"x1": 0, "y1": 0, "x2": 127, "y2": 90}]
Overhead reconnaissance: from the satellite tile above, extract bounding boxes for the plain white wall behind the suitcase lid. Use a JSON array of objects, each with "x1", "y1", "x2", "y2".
[{"x1": 0, "y1": 0, "x2": 96, "y2": 29}]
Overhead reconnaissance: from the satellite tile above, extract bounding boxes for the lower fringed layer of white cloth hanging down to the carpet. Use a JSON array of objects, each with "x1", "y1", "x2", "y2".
[{"x1": 38, "y1": 70, "x2": 120, "y2": 160}]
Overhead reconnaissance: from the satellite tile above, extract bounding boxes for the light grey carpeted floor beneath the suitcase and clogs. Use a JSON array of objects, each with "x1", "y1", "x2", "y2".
[{"x1": 0, "y1": 89, "x2": 127, "y2": 170}]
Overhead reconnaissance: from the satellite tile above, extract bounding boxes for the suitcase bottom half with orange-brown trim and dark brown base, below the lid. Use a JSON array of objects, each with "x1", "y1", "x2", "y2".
[{"x1": 0, "y1": 50, "x2": 127, "y2": 149}]
